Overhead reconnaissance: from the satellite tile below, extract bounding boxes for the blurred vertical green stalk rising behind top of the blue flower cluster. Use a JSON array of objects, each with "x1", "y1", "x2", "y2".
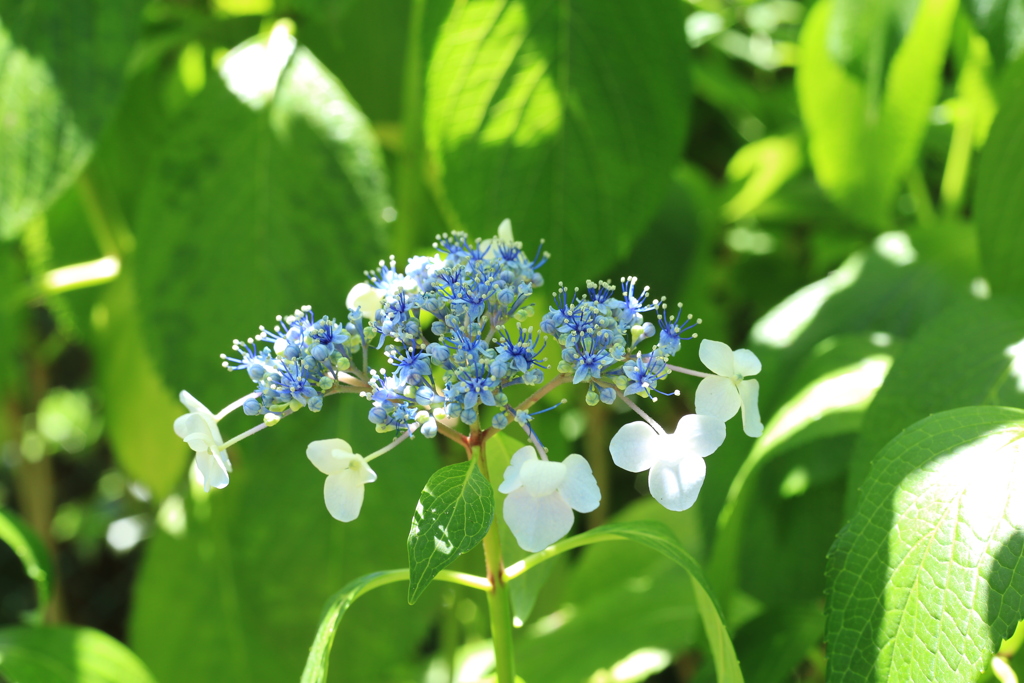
[{"x1": 391, "y1": 0, "x2": 426, "y2": 259}]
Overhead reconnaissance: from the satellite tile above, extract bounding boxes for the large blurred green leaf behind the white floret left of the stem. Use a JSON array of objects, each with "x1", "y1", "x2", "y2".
[{"x1": 129, "y1": 403, "x2": 438, "y2": 683}]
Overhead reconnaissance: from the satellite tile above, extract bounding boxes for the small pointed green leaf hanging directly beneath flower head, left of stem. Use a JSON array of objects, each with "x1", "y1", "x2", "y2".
[{"x1": 409, "y1": 460, "x2": 495, "y2": 604}]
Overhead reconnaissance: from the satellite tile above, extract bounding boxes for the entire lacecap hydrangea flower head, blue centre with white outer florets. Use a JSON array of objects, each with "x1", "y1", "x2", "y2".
[{"x1": 174, "y1": 220, "x2": 762, "y2": 551}]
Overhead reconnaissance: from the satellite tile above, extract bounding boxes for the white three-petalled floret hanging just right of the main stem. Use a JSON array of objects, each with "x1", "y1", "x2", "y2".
[{"x1": 498, "y1": 445, "x2": 601, "y2": 553}]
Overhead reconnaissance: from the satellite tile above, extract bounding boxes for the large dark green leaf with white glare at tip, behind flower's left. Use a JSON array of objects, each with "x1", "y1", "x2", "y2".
[{"x1": 135, "y1": 30, "x2": 390, "y2": 408}]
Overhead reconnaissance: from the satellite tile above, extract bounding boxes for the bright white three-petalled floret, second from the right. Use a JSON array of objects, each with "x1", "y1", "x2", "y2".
[{"x1": 608, "y1": 415, "x2": 725, "y2": 512}]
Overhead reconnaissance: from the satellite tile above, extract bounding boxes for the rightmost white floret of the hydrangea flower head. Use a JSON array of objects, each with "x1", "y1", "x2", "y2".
[{"x1": 694, "y1": 339, "x2": 764, "y2": 436}]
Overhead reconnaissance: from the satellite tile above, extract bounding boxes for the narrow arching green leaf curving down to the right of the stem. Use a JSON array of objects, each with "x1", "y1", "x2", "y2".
[{"x1": 507, "y1": 521, "x2": 743, "y2": 683}]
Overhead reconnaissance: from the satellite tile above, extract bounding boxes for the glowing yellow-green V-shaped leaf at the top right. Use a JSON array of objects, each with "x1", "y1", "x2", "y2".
[{"x1": 796, "y1": 0, "x2": 957, "y2": 226}]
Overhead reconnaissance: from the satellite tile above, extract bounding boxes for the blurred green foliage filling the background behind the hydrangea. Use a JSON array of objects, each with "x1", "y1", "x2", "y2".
[{"x1": 0, "y1": 0, "x2": 1024, "y2": 683}]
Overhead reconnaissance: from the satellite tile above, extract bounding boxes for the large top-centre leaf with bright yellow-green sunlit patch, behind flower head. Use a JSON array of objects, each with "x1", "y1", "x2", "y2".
[{"x1": 424, "y1": 0, "x2": 689, "y2": 282}]
